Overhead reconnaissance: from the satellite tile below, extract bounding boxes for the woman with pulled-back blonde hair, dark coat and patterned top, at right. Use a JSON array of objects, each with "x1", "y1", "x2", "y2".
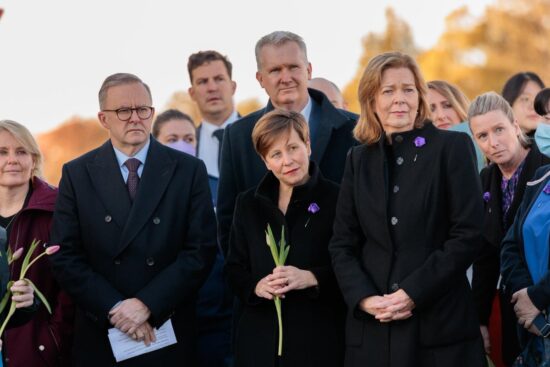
[{"x1": 468, "y1": 92, "x2": 550, "y2": 365}]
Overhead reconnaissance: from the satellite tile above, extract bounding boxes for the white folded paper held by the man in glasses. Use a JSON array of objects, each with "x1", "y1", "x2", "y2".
[{"x1": 109, "y1": 320, "x2": 178, "y2": 362}]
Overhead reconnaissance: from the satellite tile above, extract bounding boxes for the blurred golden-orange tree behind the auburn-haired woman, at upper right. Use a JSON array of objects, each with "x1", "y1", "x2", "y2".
[{"x1": 344, "y1": 0, "x2": 550, "y2": 112}]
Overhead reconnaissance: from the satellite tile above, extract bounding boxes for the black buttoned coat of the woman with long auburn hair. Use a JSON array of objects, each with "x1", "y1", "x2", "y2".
[{"x1": 329, "y1": 123, "x2": 485, "y2": 367}]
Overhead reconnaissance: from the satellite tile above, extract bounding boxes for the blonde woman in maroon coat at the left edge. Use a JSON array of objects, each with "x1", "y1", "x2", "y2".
[{"x1": 0, "y1": 120, "x2": 73, "y2": 367}]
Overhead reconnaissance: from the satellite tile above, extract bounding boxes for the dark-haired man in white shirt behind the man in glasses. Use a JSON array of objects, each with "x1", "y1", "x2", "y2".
[{"x1": 187, "y1": 50, "x2": 239, "y2": 367}]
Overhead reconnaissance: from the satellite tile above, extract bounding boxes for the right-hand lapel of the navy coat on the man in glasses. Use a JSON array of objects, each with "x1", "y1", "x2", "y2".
[{"x1": 116, "y1": 139, "x2": 177, "y2": 255}]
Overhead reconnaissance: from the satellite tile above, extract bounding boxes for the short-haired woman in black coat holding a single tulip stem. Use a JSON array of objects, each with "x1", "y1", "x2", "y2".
[{"x1": 225, "y1": 110, "x2": 345, "y2": 367}]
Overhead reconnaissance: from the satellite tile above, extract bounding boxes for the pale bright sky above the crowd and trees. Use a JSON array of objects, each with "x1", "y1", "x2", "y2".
[{"x1": 0, "y1": 0, "x2": 494, "y2": 133}]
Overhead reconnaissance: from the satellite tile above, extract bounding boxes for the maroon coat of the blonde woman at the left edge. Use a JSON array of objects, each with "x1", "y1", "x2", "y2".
[{"x1": 2, "y1": 177, "x2": 74, "y2": 367}]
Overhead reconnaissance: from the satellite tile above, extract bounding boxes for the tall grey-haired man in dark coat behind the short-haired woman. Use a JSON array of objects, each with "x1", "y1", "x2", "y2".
[{"x1": 217, "y1": 31, "x2": 357, "y2": 252}]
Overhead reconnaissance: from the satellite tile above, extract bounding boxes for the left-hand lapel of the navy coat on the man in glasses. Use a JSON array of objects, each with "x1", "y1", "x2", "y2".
[{"x1": 87, "y1": 141, "x2": 131, "y2": 228}]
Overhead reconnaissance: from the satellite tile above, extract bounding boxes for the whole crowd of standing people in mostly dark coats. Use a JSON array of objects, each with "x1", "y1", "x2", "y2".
[{"x1": 0, "y1": 31, "x2": 550, "y2": 367}]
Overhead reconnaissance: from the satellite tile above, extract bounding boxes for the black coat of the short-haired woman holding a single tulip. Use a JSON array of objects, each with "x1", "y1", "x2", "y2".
[{"x1": 225, "y1": 163, "x2": 345, "y2": 367}]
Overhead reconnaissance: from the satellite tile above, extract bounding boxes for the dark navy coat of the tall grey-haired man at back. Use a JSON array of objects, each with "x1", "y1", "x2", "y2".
[{"x1": 216, "y1": 89, "x2": 357, "y2": 253}]
